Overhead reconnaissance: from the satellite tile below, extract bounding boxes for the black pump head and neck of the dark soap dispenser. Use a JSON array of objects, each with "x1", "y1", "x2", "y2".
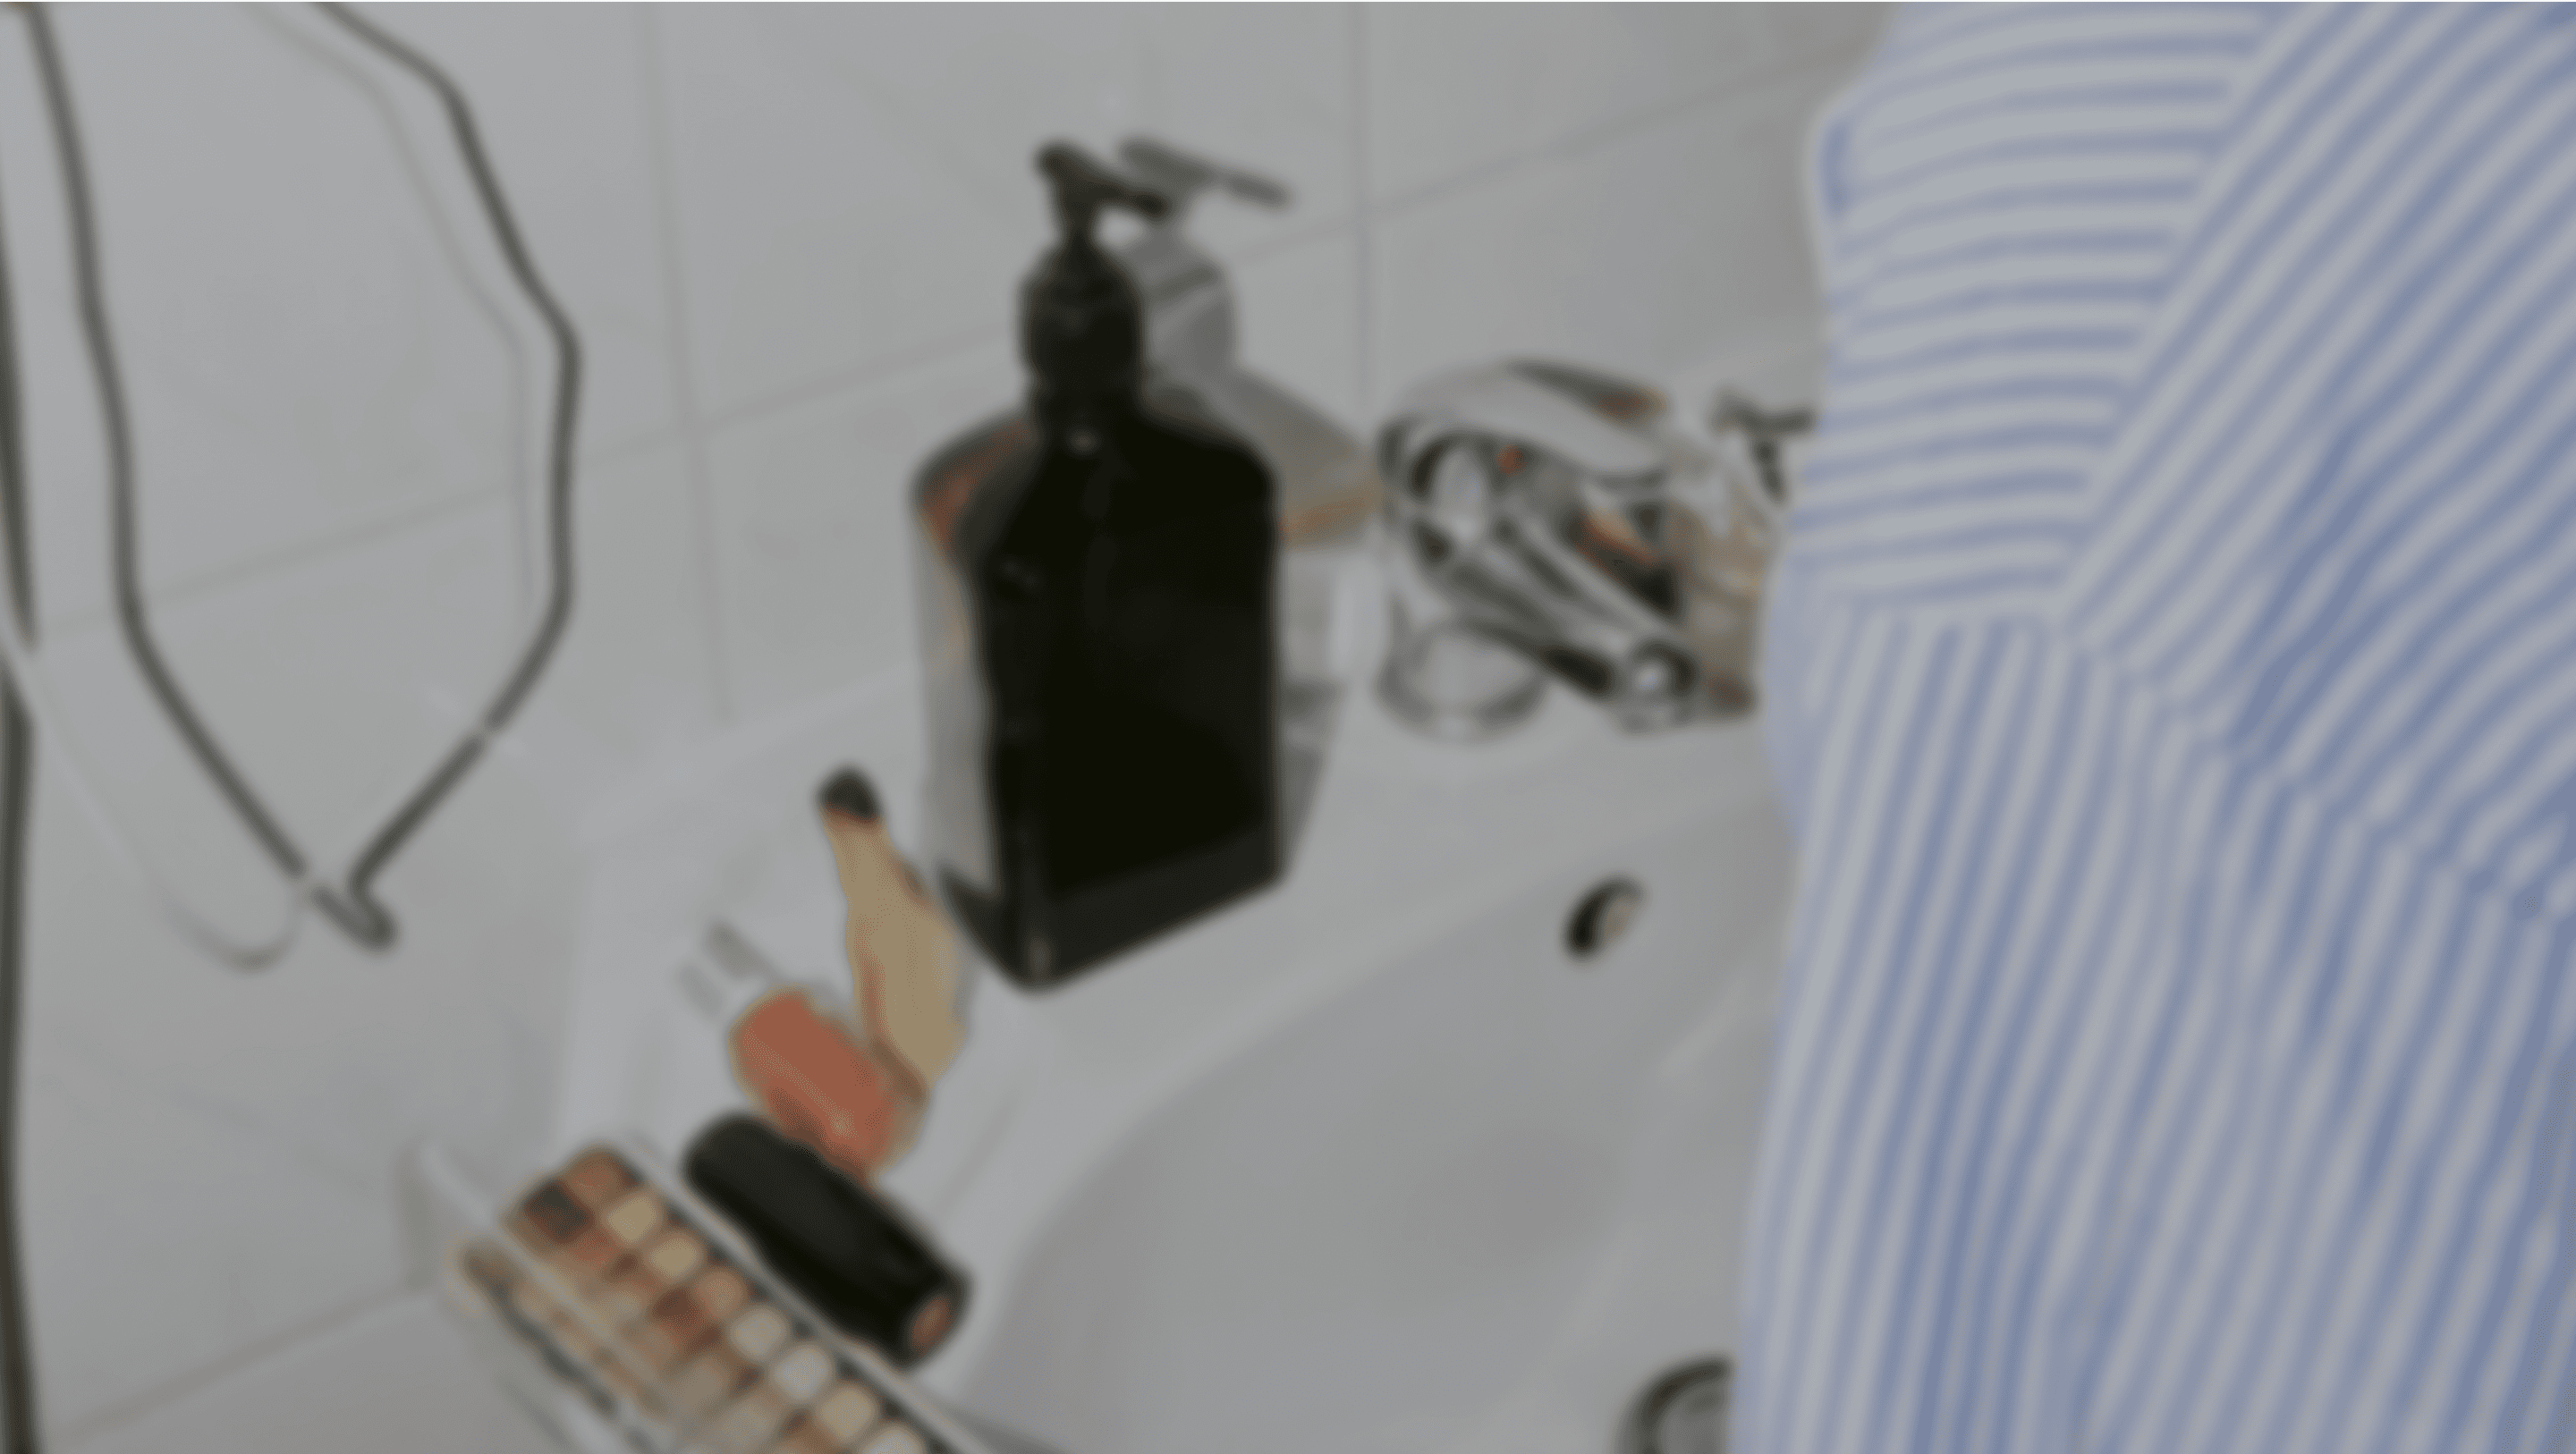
[{"x1": 1020, "y1": 141, "x2": 1170, "y2": 404}]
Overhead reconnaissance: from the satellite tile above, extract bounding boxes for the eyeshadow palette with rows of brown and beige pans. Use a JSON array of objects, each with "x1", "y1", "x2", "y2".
[{"x1": 428, "y1": 1145, "x2": 984, "y2": 1454}]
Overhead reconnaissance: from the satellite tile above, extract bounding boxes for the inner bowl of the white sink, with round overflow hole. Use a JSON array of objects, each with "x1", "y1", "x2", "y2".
[{"x1": 935, "y1": 782, "x2": 1785, "y2": 1454}]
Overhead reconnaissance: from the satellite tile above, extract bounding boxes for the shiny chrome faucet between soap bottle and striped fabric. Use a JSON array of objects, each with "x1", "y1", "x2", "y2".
[{"x1": 1378, "y1": 360, "x2": 1803, "y2": 736}]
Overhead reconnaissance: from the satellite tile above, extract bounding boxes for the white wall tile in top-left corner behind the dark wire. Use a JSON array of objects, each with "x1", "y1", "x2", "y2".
[{"x1": 0, "y1": 5, "x2": 670, "y2": 632}]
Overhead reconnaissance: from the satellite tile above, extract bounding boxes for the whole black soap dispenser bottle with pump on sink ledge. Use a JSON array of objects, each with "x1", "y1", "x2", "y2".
[{"x1": 914, "y1": 144, "x2": 1280, "y2": 988}]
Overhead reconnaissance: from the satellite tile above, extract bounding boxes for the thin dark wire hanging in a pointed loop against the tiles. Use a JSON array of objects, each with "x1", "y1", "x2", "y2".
[{"x1": 21, "y1": 5, "x2": 582, "y2": 950}]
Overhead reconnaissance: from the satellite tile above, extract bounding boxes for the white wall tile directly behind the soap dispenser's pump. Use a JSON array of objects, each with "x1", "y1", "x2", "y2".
[{"x1": 657, "y1": 3, "x2": 1350, "y2": 414}]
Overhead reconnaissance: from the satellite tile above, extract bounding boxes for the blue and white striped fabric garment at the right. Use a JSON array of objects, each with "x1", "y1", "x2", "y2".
[{"x1": 1736, "y1": 5, "x2": 2576, "y2": 1454}]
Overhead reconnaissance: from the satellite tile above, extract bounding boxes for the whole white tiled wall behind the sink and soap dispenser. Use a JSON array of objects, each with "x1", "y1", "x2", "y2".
[{"x1": 0, "y1": 3, "x2": 1880, "y2": 1449}]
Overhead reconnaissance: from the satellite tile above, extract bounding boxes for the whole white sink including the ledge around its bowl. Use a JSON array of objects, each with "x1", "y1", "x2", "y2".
[{"x1": 538, "y1": 620, "x2": 1791, "y2": 1454}]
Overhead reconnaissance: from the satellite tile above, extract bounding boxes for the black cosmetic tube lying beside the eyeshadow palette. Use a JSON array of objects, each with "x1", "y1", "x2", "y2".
[{"x1": 685, "y1": 1114, "x2": 966, "y2": 1364}]
